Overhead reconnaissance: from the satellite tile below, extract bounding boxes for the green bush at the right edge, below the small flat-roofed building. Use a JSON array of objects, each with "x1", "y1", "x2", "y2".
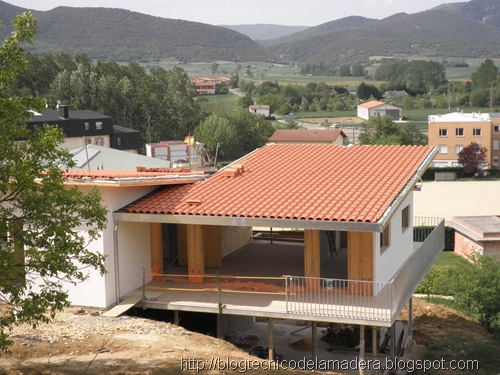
[{"x1": 452, "y1": 253, "x2": 500, "y2": 332}]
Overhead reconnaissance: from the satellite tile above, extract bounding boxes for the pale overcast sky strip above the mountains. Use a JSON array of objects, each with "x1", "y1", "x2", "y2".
[{"x1": 6, "y1": 0, "x2": 464, "y2": 26}]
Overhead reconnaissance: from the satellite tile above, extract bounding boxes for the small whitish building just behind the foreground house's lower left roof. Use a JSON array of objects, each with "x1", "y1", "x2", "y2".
[{"x1": 146, "y1": 141, "x2": 209, "y2": 169}]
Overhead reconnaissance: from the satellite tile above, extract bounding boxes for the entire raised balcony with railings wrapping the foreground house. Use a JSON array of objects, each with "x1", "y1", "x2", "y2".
[{"x1": 132, "y1": 218, "x2": 444, "y2": 327}]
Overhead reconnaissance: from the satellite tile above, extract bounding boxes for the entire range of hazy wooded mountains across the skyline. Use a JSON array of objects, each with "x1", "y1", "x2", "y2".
[{"x1": 0, "y1": 0, "x2": 500, "y2": 65}]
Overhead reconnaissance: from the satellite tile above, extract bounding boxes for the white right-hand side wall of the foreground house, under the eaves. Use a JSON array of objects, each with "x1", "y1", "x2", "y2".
[{"x1": 373, "y1": 192, "x2": 413, "y2": 282}]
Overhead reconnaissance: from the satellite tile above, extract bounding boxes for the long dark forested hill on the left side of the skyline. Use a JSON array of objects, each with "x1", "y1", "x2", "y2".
[{"x1": 0, "y1": 1, "x2": 273, "y2": 61}]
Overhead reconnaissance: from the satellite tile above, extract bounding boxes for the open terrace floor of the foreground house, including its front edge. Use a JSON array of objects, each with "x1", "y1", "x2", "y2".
[{"x1": 125, "y1": 241, "x2": 391, "y2": 326}]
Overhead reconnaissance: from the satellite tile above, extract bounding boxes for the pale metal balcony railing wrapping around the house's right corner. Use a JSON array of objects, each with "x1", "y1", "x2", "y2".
[{"x1": 286, "y1": 217, "x2": 444, "y2": 322}]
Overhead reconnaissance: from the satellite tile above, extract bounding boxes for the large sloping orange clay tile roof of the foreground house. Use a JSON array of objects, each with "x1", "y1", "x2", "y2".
[{"x1": 122, "y1": 144, "x2": 433, "y2": 223}]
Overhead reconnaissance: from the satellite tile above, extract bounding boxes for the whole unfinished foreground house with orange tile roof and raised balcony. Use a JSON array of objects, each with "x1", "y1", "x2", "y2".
[{"x1": 50, "y1": 143, "x2": 444, "y2": 358}]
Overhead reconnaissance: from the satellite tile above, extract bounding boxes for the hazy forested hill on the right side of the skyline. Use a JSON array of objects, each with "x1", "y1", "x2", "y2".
[{"x1": 270, "y1": 10, "x2": 500, "y2": 64}]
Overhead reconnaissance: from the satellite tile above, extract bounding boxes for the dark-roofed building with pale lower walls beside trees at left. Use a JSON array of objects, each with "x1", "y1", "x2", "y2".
[{"x1": 26, "y1": 105, "x2": 144, "y2": 153}]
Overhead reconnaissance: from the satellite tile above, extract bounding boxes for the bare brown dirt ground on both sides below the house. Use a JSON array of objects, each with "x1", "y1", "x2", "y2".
[{"x1": 0, "y1": 299, "x2": 491, "y2": 375}]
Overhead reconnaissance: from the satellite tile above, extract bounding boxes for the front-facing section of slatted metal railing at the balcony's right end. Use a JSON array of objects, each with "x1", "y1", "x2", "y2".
[{"x1": 286, "y1": 276, "x2": 391, "y2": 322}]
